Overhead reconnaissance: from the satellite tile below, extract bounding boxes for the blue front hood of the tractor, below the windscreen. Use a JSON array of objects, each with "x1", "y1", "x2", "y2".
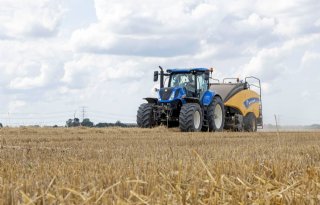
[{"x1": 159, "y1": 87, "x2": 186, "y2": 103}]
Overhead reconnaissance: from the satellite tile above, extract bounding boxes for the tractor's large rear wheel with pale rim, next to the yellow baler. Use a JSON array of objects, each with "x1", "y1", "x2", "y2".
[{"x1": 208, "y1": 97, "x2": 225, "y2": 132}]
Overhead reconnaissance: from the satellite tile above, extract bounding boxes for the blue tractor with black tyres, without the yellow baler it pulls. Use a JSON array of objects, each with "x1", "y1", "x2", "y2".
[{"x1": 137, "y1": 66, "x2": 225, "y2": 132}]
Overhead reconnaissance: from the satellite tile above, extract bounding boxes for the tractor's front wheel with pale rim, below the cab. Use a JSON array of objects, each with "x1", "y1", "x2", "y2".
[{"x1": 179, "y1": 103, "x2": 203, "y2": 132}]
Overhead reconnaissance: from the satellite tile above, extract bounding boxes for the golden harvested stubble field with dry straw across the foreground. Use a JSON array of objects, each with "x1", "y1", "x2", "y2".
[{"x1": 0, "y1": 128, "x2": 320, "y2": 204}]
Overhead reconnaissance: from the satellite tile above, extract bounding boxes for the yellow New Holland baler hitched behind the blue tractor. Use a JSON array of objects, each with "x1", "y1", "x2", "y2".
[{"x1": 210, "y1": 77, "x2": 263, "y2": 131}]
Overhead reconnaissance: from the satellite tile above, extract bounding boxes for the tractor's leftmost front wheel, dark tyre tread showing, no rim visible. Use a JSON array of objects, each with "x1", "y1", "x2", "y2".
[{"x1": 137, "y1": 103, "x2": 156, "y2": 128}]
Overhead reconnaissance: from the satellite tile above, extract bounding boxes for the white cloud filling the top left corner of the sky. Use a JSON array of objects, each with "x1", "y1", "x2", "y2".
[{"x1": 0, "y1": 0, "x2": 64, "y2": 39}]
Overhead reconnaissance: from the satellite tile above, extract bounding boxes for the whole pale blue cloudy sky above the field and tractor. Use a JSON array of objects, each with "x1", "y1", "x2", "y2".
[{"x1": 0, "y1": 0, "x2": 320, "y2": 126}]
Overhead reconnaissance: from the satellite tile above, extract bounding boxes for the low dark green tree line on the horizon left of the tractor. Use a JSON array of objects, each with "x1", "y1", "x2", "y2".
[{"x1": 66, "y1": 118, "x2": 136, "y2": 128}]
